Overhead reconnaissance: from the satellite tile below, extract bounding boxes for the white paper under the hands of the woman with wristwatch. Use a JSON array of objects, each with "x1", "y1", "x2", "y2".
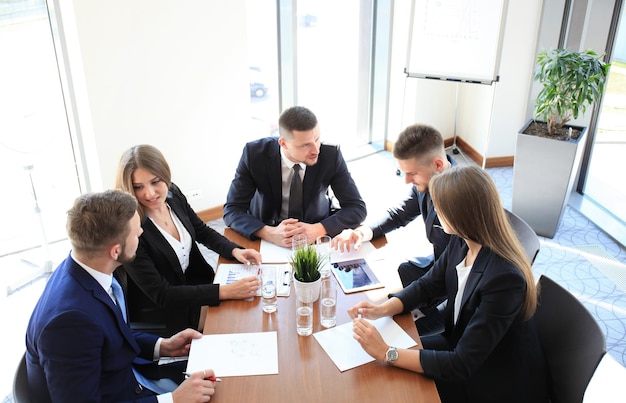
[{"x1": 313, "y1": 316, "x2": 417, "y2": 372}]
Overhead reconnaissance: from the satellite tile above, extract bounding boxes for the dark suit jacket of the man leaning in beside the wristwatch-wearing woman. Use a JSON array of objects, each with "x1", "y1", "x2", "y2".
[{"x1": 371, "y1": 155, "x2": 456, "y2": 259}]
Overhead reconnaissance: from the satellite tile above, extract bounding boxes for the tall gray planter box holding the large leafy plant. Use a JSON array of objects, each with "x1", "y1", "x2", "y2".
[{"x1": 512, "y1": 120, "x2": 587, "y2": 238}]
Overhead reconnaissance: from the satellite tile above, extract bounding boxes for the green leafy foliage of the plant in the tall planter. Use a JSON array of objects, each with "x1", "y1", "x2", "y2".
[{"x1": 534, "y1": 49, "x2": 610, "y2": 136}]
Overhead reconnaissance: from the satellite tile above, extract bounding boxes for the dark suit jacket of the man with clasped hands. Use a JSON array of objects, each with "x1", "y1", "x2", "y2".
[{"x1": 224, "y1": 137, "x2": 367, "y2": 239}]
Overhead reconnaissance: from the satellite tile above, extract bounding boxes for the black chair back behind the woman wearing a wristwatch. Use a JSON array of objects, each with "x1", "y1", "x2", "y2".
[{"x1": 535, "y1": 275, "x2": 606, "y2": 403}]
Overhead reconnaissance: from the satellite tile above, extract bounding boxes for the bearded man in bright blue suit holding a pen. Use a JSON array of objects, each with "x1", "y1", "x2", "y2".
[{"x1": 26, "y1": 191, "x2": 215, "y2": 402}]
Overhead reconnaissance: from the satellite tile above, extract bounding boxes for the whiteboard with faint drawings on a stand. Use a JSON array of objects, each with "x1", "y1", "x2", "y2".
[{"x1": 405, "y1": 0, "x2": 506, "y2": 84}]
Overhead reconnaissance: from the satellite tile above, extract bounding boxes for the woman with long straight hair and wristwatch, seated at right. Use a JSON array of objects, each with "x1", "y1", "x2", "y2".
[{"x1": 349, "y1": 166, "x2": 548, "y2": 403}]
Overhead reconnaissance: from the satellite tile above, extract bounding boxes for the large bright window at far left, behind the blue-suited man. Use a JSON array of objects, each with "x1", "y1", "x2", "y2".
[{"x1": 0, "y1": 0, "x2": 80, "y2": 286}]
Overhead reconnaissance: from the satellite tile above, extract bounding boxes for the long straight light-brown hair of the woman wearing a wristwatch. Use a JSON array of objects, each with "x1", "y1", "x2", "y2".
[{"x1": 428, "y1": 165, "x2": 538, "y2": 319}]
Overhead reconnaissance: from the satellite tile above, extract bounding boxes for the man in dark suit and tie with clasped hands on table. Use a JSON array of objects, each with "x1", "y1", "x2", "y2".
[{"x1": 224, "y1": 106, "x2": 367, "y2": 247}]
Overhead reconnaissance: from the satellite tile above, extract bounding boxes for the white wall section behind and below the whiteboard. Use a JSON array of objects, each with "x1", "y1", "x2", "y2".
[{"x1": 389, "y1": 0, "x2": 543, "y2": 158}]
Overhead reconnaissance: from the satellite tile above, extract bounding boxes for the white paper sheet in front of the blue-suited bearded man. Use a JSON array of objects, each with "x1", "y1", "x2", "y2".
[{"x1": 187, "y1": 331, "x2": 278, "y2": 377}]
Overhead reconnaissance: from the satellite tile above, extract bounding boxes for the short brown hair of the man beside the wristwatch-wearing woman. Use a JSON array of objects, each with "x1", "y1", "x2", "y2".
[{"x1": 393, "y1": 123, "x2": 446, "y2": 163}]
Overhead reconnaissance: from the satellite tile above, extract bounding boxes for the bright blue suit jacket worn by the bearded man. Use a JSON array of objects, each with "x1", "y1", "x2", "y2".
[{"x1": 26, "y1": 257, "x2": 158, "y2": 402}]
